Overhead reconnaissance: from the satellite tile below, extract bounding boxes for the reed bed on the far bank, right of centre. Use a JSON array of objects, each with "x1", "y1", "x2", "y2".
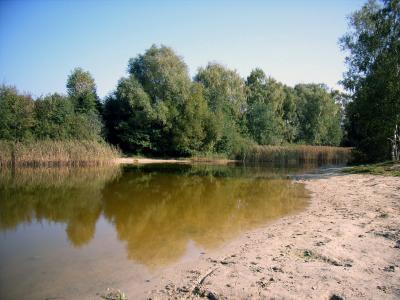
[{"x1": 238, "y1": 145, "x2": 352, "y2": 164}]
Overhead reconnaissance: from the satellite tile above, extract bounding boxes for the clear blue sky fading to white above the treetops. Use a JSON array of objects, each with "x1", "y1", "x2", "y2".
[{"x1": 0, "y1": 0, "x2": 365, "y2": 96}]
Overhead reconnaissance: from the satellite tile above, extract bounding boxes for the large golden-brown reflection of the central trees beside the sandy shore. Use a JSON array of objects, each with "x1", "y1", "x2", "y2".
[{"x1": 103, "y1": 166, "x2": 306, "y2": 265}]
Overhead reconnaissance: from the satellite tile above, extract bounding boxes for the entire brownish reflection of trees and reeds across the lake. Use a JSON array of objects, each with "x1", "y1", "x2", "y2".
[{"x1": 0, "y1": 165, "x2": 306, "y2": 266}]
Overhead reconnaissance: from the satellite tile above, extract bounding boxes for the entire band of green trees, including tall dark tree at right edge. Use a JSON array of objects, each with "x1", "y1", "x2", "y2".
[{"x1": 0, "y1": 0, "x2": 400, "y2": 161}]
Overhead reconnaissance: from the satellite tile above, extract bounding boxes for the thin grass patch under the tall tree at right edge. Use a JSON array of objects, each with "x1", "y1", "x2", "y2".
[{"x1": 343, "y1": 161, "x2": 400, "y2": 177}]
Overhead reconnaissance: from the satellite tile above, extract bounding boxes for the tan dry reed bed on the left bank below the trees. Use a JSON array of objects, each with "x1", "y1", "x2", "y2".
[{"x1": 0, "y1": 140, "x2": 120, "y2": 167}]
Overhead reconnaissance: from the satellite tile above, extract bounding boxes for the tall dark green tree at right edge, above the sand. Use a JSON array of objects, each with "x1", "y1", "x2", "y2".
[{"x1": 340, "y1": 0, "x2": 400, "y2": 161}]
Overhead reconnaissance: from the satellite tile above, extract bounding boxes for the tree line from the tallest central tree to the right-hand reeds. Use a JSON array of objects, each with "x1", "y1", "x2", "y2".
[{"x1": 103, "y1": 45, "x2": 342, "y2": 155}]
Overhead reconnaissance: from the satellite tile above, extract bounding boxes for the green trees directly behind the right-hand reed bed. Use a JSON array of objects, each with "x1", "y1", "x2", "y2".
[{"x1": 246, "y1": 74, "x2": 342, "y2": 145}]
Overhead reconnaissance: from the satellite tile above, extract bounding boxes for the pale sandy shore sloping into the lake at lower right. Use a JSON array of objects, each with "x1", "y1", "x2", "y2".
[{"x1": 134, "y1": 175, "x2": 400, "y2": 299}]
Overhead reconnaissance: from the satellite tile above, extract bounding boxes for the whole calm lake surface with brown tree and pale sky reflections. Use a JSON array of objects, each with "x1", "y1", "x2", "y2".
[{"x1": 0, "y1": 165, "x2": 315, "y2": 299}]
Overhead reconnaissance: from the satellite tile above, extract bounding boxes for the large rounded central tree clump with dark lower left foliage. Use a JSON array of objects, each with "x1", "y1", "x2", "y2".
[{"x1": 104, "y1": 45, "x2": 208, "y2": 155}]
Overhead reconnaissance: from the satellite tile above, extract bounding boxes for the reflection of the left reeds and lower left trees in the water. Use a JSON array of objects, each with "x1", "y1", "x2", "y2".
[{"x1": 0, "y1": 167, "x2": 120, "y2": 246}]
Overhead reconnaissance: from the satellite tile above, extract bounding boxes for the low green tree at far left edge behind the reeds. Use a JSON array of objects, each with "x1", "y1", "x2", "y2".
[{"x1": 0, "y1": 85, "x2": 35, "y2": 141}]
